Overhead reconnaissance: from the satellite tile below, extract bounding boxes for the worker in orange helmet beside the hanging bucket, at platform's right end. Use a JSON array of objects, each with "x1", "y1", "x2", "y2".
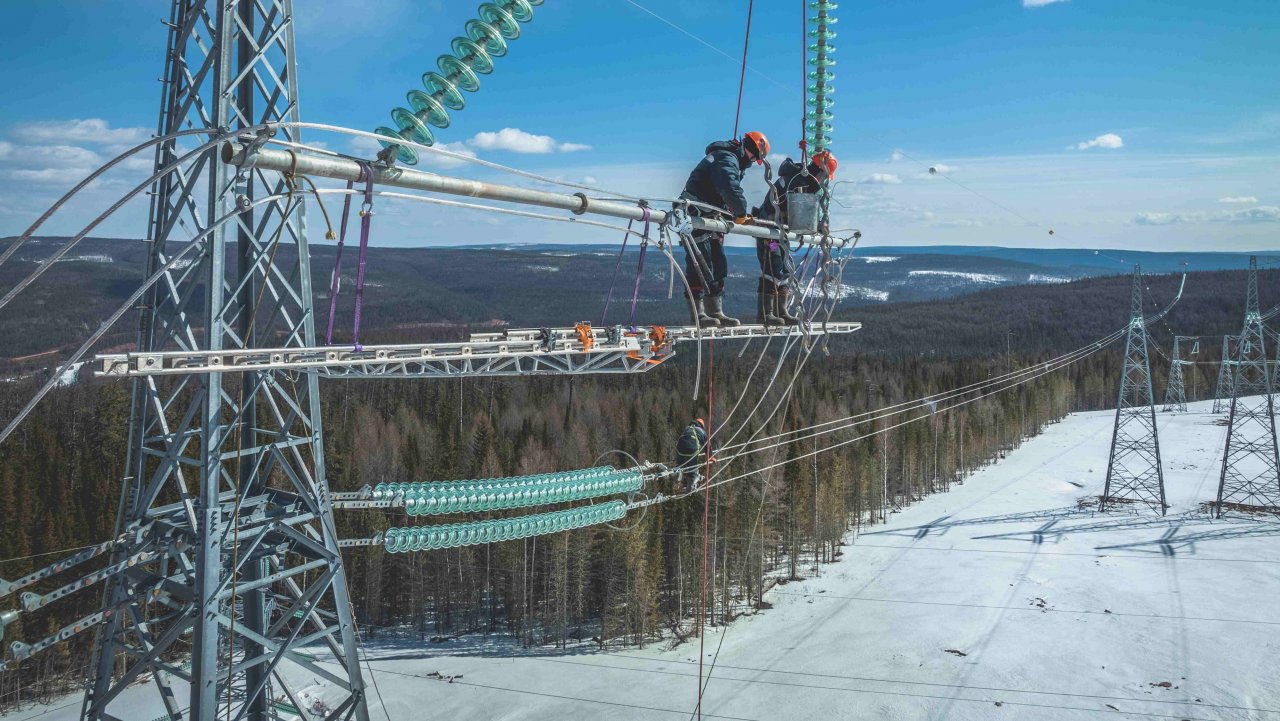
[{"x1": 755, "y1": 150, "x2": 836, "y2": 325}]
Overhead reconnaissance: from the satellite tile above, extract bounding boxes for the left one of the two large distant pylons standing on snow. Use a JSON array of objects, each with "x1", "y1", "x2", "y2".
[{"x1": 1100, "y1": 265, "x2": 1167, "y2": 515}]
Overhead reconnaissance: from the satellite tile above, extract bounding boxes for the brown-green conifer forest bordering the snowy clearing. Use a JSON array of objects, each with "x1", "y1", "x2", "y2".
[{"x1": 0, "y1": 263, "x2": 1259, "y2": 704}]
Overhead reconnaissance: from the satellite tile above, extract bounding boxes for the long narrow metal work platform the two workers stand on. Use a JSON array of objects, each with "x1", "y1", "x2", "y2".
[{"x1": 95, "y1": 321, "x2": 863, "y2": 378}]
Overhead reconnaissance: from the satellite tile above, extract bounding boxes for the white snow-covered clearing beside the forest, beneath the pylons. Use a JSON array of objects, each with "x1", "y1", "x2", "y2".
[{"x1": 14, "y1": 403, "x2": 1280, "y2": 721}]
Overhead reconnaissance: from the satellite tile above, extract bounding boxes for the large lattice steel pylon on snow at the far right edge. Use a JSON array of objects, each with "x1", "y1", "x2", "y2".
[{"x1": 1216, "y1": 256, "x2": 1280, "y2": 517}]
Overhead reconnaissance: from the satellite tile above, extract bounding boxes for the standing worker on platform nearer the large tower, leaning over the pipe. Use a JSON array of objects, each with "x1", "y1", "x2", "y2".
[{"x1": 680, "y1": 131, "x2": 769, "y2": 327}]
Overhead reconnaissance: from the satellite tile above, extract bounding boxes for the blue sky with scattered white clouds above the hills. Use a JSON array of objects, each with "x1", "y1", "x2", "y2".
[{"x1": 0, "y1": 0, "x2": 1280, "y2": 250}]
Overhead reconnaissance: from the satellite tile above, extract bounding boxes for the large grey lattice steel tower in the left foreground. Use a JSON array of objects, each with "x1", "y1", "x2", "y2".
[{"x1": 82, "y1": 0, "x2": 367, "y2": 721}]
